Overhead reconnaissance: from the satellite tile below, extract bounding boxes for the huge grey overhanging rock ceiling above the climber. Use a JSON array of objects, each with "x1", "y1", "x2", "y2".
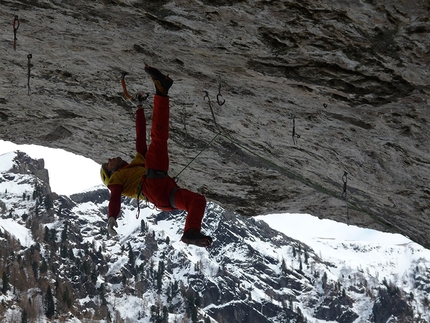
[{"x1": 0, "y1": 0, "x2": 430, "y2": 248}]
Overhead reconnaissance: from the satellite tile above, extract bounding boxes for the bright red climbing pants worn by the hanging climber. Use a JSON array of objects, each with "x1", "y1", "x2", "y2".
[{"x1": 142, "y1": 95, "x2": 206, "y2": 232}]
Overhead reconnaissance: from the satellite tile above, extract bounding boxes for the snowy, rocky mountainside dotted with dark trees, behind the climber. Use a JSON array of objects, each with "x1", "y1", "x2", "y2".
[{"x1": 0, "y1": 154, "x2": 430, "y2": 323}]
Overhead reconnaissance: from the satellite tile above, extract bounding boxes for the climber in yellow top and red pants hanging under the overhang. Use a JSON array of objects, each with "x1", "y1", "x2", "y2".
[{"x1": 100, "y1": 64, "x2": 212, "y2": 247}]
